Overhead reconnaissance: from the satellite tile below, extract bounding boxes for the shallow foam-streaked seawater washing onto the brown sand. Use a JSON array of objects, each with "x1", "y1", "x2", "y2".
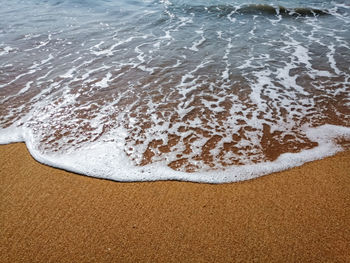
[{"x1": 0, "y1": 0, "x2": 350, "y2": 183}]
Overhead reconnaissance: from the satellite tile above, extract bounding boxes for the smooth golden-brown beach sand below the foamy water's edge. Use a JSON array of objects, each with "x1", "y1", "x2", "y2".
[{"x1": 0, "y1": 144, "x2": 350, "y2": 263}]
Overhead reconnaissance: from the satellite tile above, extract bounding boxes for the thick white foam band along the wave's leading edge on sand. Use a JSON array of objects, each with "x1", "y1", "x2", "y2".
[{"x1": 0, "y1": 125, "x2": 350, "y2": 183}]
